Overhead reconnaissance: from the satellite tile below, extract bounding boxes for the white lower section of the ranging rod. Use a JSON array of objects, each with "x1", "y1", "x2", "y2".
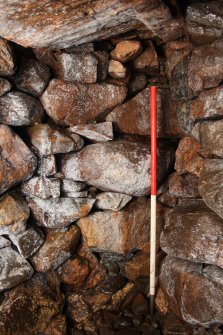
[{"x1": 149, "y1": 195, "x2": 156, "y2": 296}]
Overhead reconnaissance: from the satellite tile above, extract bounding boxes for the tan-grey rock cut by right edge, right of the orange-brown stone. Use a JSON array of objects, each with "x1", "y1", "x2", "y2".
[{"x1": 193, "y1": 120, "x2": 223, "y2": 158}]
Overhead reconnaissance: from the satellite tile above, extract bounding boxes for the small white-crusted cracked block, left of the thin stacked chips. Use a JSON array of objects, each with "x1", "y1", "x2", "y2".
[{"x1": 21, "y1": 177, "x2": 60, "y2": 199}]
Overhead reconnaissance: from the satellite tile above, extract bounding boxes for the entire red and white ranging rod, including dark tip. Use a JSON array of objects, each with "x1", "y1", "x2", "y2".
[{"x1": 149, "y1": 86, "x2": 157, "y2": 314}]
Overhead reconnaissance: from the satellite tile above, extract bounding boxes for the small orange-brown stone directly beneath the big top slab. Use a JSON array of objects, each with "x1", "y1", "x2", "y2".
[{"x1": 110, "y1": 40, "x2": 142, "y2": 63}]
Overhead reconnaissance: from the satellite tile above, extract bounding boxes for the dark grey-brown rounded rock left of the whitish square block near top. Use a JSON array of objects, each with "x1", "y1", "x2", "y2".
[{"x1": 13, "y1": 58, "x2": 50, "y2": 97}]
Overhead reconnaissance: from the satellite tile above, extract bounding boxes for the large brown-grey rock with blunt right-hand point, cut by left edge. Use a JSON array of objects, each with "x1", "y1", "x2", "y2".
[{"x1": 0, "y1": 125, "x2": 37, "y2": 194}]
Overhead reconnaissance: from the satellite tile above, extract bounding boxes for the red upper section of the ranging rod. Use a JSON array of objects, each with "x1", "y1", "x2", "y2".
[{"x1": 150, "y1": 86, "x2": 157, "y2": 195}]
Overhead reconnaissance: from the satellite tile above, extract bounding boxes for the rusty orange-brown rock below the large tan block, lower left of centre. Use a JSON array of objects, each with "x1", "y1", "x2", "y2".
[{"x1": 57, "y1": 256, "x2": 90, "y2": 289}]
